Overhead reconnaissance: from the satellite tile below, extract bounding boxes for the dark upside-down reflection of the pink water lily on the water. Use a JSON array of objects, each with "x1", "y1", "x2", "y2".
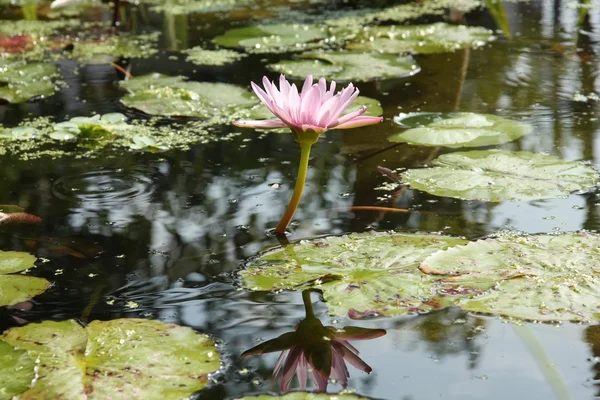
[{"x1": 242, "y1": 290, "x2": 386, "y2": 392}]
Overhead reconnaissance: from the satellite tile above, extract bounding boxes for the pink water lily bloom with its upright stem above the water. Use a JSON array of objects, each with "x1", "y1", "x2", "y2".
[{"x1": 233, "y1": 74, "x2": 383, "y2": 234}]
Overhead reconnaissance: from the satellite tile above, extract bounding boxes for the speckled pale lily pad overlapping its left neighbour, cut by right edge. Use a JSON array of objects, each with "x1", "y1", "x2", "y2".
[{"x1": 420, "y1": 232, "x2": 600, "y2": 321}]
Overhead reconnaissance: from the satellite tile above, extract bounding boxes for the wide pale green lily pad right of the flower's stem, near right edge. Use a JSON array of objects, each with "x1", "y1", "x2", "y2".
[{"x1": 402, "y1": 150, "x2": 598, "y2": 202}]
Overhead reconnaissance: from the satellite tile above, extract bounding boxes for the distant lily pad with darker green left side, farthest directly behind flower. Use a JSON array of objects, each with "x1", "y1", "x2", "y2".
[{"x1": 213, "y1": 24, "x2": 329, "y2": 53}]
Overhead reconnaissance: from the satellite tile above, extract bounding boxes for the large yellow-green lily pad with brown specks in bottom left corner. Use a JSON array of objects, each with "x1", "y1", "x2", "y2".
[{"x1": 0, "y1": 318, "x2": 219, "y2": 400}]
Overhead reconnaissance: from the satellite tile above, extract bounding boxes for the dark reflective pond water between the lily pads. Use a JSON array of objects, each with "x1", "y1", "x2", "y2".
[{"x1": 0, "y1": 0, "x2": 600, "y2": 400}]
